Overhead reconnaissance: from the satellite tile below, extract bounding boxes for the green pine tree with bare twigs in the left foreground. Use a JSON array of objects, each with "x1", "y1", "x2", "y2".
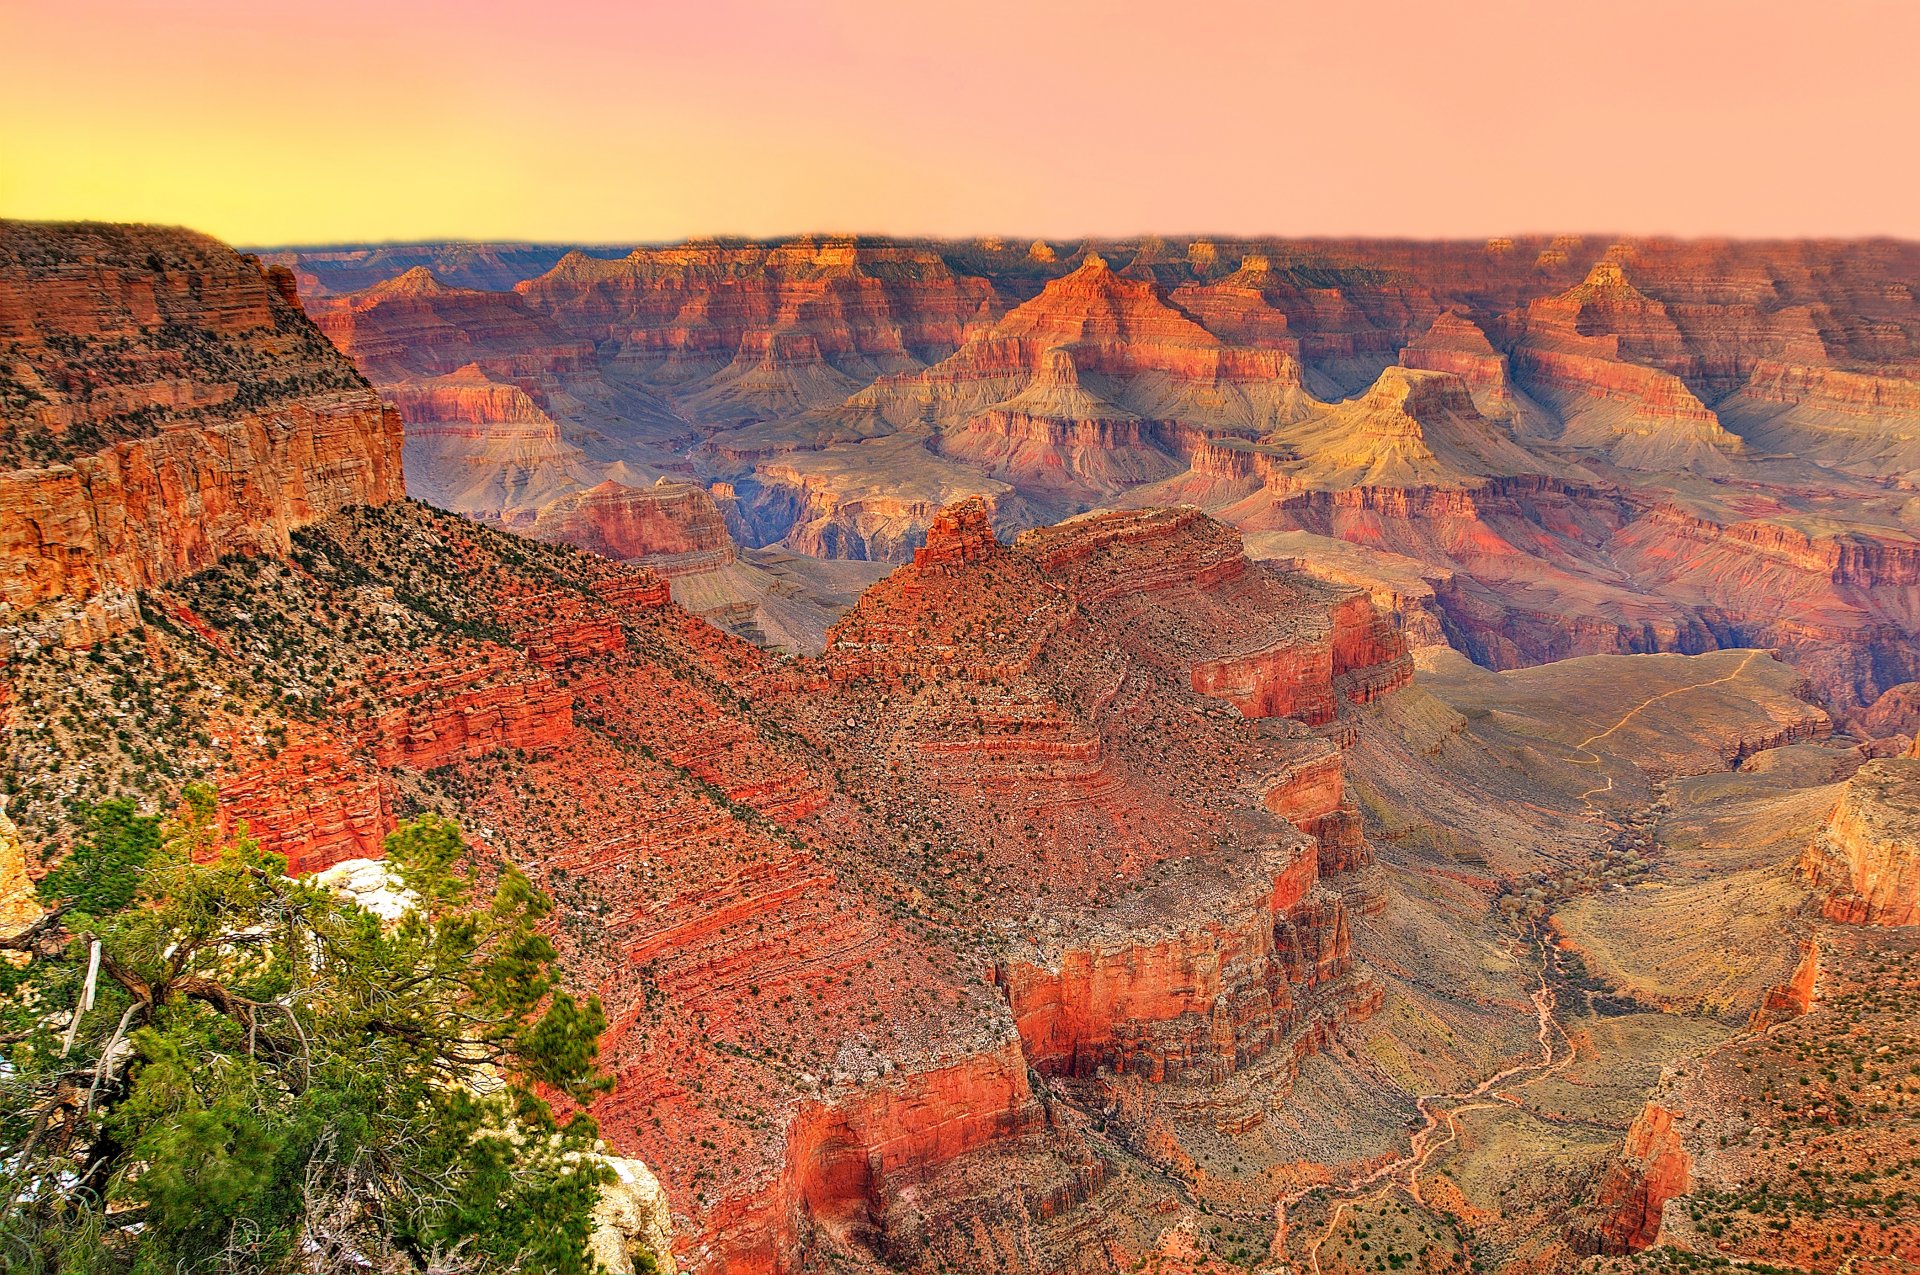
[{"x1": 0, "y1": 787, "x2": 605, "y2": 1275}]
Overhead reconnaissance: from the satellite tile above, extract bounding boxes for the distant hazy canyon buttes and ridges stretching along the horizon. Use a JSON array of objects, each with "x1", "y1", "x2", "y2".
[{"x1": 265, "y1": 236, "x2": 1920, "y2": 734}]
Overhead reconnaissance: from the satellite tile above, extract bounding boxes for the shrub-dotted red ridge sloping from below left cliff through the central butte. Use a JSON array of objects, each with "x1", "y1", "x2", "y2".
[{"x1": 10, "y1": 472, "x2": 1405, "y2": 1271}]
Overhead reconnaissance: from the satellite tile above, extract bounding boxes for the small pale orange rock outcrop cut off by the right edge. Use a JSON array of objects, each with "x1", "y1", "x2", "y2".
[{"x1": 1801, "y1": 757, "x2": 1920, "y2": 926}]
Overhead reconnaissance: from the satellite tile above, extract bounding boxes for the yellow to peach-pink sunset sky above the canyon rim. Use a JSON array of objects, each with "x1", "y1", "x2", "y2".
[{"x1": 0, "y1": 0, "x2": 1920, "y2": 246}]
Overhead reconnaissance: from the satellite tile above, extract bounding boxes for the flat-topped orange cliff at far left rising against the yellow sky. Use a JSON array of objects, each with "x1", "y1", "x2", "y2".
[{"x1": 0, "y1": 223, "x2": 403, "y2": 641}]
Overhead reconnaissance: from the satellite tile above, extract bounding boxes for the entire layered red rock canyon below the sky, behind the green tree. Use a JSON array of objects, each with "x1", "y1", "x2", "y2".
[{"x1": 0, "y1": 223, "x2": 1920, "y2": 1275}]
